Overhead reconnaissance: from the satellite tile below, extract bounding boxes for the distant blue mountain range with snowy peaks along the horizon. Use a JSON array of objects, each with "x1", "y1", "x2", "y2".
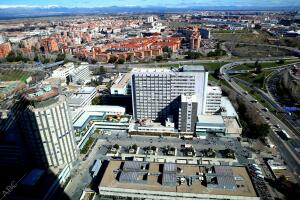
[{"x1": 0, "y1": 5, "x2": 300, "y2": 19}]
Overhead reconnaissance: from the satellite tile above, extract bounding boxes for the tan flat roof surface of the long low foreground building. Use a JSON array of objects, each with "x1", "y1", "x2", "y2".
[{"x1": 99, "y1": 160, "x2": 257, "y2": 197}]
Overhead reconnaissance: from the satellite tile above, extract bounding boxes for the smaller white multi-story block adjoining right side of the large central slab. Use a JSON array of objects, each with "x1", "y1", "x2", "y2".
[{"x1": 205, "y1": 86, "x2": 222, "y2": 114}]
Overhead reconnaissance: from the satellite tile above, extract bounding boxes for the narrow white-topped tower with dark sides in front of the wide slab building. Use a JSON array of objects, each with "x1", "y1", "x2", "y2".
[{"x1": 178, "y1": 95, "x2": 198, "y2": 132}]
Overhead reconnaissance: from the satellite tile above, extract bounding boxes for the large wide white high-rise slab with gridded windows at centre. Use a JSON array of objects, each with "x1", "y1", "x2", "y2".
[{"x1": 131, "y1": 66, "x2": 208, "y2": 123}]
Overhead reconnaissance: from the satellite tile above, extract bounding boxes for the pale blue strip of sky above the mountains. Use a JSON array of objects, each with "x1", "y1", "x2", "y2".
[{"x1": 0, "y1": 0, "x2": 300, "y2": 8}]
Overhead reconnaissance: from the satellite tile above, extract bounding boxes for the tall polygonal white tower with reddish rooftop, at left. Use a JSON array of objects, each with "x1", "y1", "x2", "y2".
[{"x1": 20, "y1": 85, "x2": 78, "y2": 167}]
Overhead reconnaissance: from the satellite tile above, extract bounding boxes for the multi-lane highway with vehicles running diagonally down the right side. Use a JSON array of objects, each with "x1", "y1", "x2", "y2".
[{"x1": 220, "y1": 63, "x2": 300, "y2": 182}]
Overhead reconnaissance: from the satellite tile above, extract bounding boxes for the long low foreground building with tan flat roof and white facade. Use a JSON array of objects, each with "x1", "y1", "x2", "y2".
[{"x1": 99, "y1": 160, "x2": 259, "y2": 200}]
